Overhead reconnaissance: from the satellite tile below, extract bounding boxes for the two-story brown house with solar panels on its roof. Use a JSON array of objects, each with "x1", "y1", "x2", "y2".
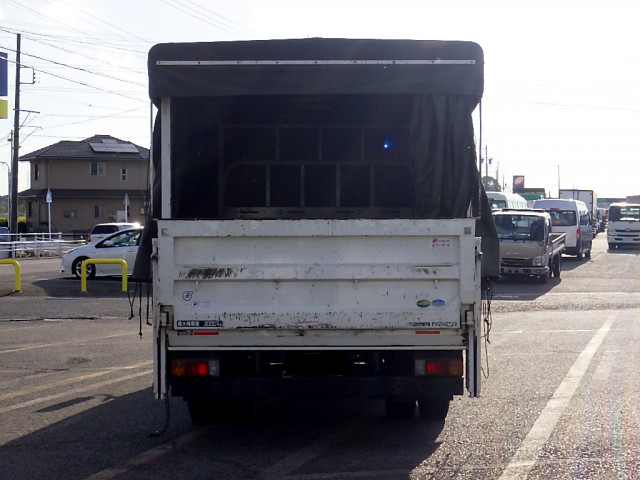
[{"x1": 19, "y1": 135, "x2": 149, "y2": 233}]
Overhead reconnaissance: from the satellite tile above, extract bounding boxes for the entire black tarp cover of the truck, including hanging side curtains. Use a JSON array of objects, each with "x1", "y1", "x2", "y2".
[{"x1": 133, "y1": 38, "x2": 499, "y2": 280}]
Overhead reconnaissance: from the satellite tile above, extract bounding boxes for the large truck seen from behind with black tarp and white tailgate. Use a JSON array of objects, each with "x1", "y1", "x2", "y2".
[{"x1": 133, "y1": 38, "x2": 499, "y2": 421}]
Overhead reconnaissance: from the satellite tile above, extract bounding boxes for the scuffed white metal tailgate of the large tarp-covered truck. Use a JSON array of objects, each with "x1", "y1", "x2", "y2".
[{"x1": 154, "y1": 219, "x2": 479, "y2": 330}]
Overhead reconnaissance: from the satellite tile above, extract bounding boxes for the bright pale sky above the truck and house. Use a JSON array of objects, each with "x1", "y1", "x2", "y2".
[{"x1": 0, "y1": 0, "x2": 640, "y2": 197}]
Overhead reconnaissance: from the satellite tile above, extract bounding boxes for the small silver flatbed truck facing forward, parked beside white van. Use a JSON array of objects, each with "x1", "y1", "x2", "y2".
[{"x1": 493, "y1": 209, "x2": 566, "y2": 283}]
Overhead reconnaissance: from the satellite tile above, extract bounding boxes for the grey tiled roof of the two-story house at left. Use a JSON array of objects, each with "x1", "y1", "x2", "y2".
[{"x1": 20, "y1": 135, "x2": 149, "y2": 161}]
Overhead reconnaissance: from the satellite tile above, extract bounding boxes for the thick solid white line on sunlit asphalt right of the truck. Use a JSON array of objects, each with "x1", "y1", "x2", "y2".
[{"x1": 499, "y1": 316, "x2": 614, "y2": 480}]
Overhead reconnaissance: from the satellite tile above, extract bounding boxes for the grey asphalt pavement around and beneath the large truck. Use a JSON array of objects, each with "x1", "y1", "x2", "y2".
[{"x1": 0, "y1": 235, "x2": 640, "y2": 480}]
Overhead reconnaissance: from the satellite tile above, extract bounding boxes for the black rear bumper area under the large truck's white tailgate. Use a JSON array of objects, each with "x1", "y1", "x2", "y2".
[{"x1": 168, "y1": 350, "x2": 464, "y2": 401}]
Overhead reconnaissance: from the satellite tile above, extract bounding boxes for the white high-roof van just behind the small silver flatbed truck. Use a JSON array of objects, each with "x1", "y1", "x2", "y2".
[{"x1": 533, "y1": 198, "x2": 593, "y2": 258}]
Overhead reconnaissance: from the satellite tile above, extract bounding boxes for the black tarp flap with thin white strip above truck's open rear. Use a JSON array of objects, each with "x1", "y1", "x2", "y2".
[{"x1": 148, "y1": 38, "x2": 484, "y2": 101}]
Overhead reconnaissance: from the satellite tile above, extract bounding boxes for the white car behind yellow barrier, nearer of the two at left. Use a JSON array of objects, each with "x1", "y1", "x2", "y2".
[{"x1": 60, "y1": 228, "x2": 142, "y2": 278}]
